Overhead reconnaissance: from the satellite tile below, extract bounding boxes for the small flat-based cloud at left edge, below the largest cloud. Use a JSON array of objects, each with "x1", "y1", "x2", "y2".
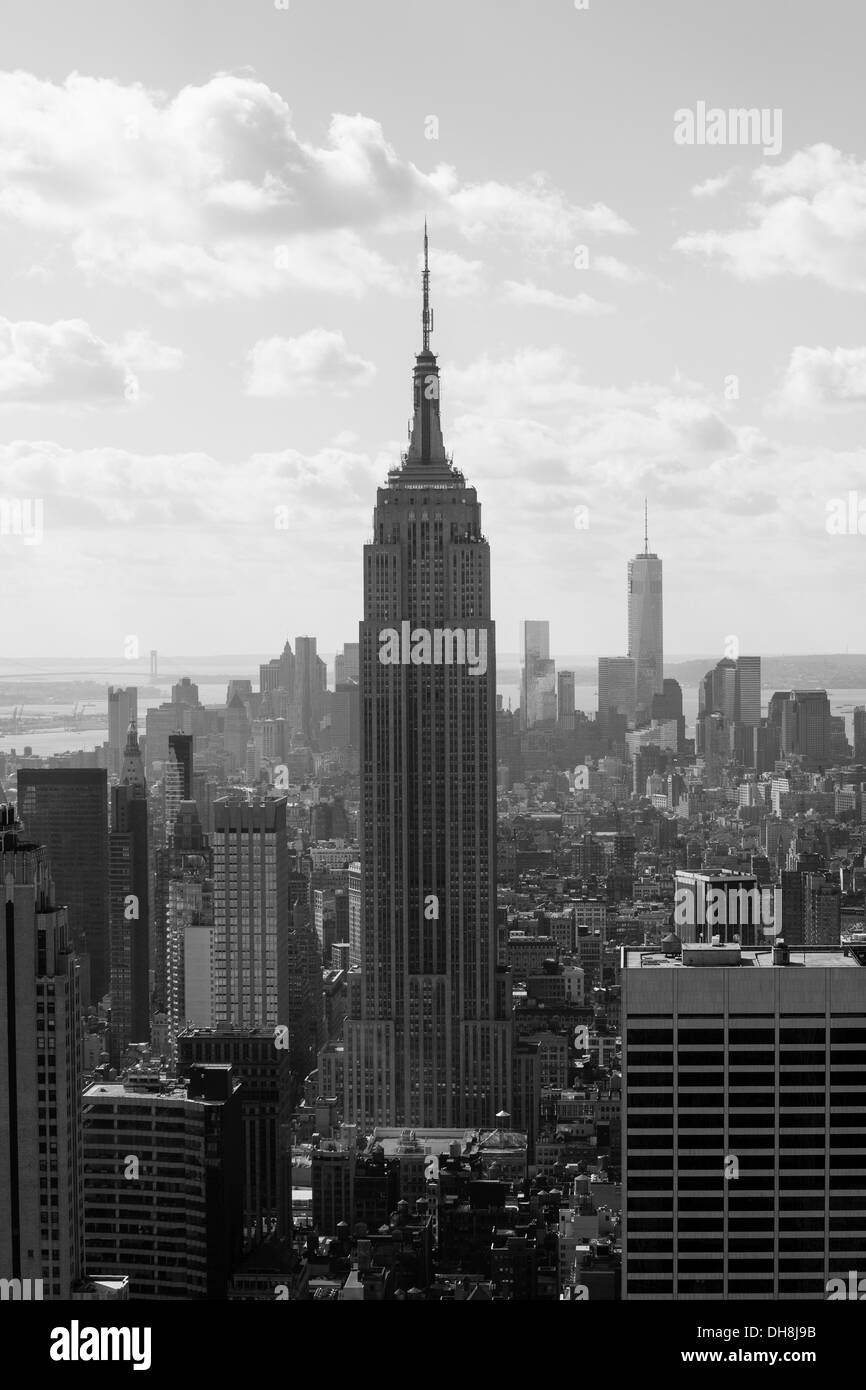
[{"x1": 0, "y1": 318, "x2": 182, "y2": 404}]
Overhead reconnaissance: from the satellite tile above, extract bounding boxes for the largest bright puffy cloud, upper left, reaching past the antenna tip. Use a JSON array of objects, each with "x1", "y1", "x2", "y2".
[{"x1": 0, "y1": 72, "x2": 630, "y2": 303}]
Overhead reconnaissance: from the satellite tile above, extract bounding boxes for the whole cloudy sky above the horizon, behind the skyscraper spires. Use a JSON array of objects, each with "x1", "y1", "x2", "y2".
[{"x1": 0, "y1": 0, "x2": 866, "y2": 657}]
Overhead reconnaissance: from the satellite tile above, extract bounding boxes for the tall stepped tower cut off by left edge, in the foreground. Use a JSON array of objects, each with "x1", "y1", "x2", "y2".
[{"x1": 0, "y1": 806, "x2": 83, "y2": 1300}]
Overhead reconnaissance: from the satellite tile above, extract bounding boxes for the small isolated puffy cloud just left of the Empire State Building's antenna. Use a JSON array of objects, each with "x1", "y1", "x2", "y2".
[{"x1": 245, "y1": 328, "x2": 375, "y2": 398}]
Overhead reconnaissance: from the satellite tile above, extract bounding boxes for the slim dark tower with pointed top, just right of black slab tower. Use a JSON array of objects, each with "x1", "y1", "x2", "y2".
[{"x1": 108, "y1": 724, "x2": 150, "y2": 1065}]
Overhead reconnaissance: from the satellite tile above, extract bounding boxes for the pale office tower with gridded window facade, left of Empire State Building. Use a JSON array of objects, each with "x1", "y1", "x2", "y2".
[{"x1": 213, "y1": 798, "x2": 289, "y2": 1027}]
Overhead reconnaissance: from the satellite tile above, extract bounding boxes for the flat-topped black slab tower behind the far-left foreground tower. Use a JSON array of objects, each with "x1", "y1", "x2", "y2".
[{"x1": 18, "y1": 767, "x2": 111, "y2": 1006}]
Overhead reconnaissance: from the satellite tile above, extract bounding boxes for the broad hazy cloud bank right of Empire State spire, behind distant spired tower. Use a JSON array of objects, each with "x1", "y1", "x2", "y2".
[{"x1": 443, "y1": 348, "x2": 866, "y2": 649}]
